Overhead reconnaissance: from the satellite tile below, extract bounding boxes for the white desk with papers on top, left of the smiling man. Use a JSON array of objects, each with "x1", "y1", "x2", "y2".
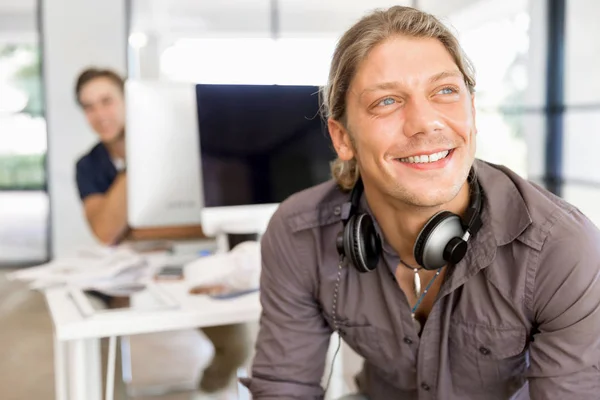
[{"x1": 45, "y1": 282, "x2": 261, "y2": 400}]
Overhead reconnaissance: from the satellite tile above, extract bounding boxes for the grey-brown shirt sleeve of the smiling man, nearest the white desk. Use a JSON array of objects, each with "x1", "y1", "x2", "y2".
[{"x1": 242, "y1": 208, "x2": 332, "y2": 400}]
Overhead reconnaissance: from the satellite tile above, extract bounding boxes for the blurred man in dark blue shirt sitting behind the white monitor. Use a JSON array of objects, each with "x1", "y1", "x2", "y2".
[{"x1": 75, "y1": 68, "x2": 250, "y2": 392}]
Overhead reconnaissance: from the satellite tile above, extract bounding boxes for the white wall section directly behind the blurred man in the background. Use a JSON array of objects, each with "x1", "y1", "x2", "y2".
[{"x1": 41, "y1": 0, "x2": 127, "y2": 257}]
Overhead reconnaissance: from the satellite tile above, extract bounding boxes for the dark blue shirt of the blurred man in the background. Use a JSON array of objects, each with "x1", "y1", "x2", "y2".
[{"x1": 76, "y1": 143, "x2": 117, "y2": 200}]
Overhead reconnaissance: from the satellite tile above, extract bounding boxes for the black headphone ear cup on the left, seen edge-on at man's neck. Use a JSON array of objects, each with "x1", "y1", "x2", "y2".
[{"x1": 344, "y1": 214, "x2": 381, "y2": 272}]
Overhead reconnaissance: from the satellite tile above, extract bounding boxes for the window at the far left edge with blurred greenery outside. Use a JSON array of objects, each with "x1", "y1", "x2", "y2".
[{"x1": 0, "y1": 19, "x2": 49, "y2": 266}]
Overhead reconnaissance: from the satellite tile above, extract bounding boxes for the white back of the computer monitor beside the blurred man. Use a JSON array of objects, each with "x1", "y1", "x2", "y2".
[{"x1": 125, "y1": 80, "x2": 203, "y2": 228}]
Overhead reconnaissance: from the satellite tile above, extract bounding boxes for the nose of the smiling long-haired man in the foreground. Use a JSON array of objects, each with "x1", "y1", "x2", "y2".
[{"x1": 403, "y1": 98, "x2": 444, "y2": 137}]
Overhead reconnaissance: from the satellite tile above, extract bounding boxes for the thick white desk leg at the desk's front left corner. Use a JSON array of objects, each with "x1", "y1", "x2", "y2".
[{"x1": 68, "y1": 339, "x2": 102, "y2": 400}]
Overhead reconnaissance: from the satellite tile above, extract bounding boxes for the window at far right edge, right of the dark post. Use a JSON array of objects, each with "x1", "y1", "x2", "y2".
[{"x1": 563, "y1": 0, "x2": 600, "y2": 226}]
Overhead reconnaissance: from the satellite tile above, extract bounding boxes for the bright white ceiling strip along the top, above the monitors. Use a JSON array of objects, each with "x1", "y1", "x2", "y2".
[{"x1": 131, "y1": 0, "x2": 481, "y2": 37}]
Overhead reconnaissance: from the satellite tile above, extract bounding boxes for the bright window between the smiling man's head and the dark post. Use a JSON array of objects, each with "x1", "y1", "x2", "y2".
[{"x1": 436, "y1": 0, "x2": 545, "y2": 179}]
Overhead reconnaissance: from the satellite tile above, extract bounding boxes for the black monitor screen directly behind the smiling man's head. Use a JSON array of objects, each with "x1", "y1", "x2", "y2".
[{"x1": 196, "y1": 85, "x2": 335, "y2": 207}]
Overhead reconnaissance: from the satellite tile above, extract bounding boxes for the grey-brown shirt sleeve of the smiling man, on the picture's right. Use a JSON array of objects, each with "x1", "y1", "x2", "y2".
[{"x1": 529, "y1": 211, "x2": 600, "y2": 400}]
